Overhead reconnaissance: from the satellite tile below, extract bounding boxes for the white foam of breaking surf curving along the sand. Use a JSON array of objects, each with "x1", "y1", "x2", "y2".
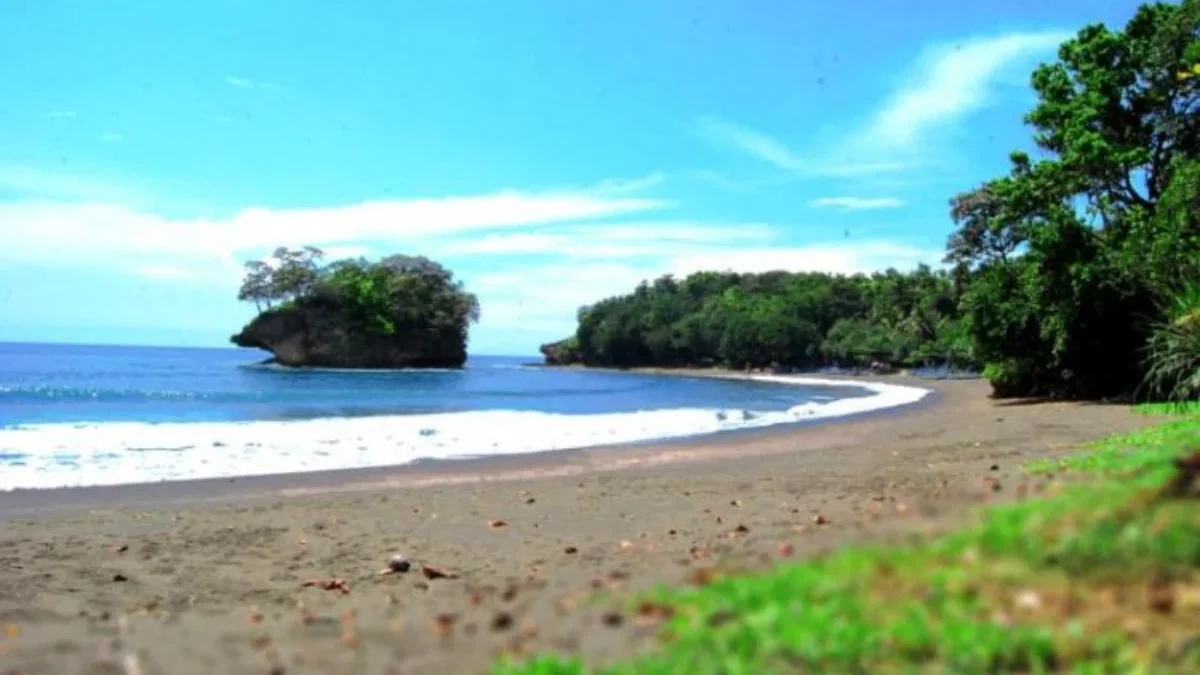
[{"x1": 0, "y1": 375, "x2": 929, "y2": 490}]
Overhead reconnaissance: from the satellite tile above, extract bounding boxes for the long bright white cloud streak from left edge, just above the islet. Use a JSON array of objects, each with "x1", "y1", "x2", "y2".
[{"x1": 0, "y1": 181, "x2": 667, "y2": 276}]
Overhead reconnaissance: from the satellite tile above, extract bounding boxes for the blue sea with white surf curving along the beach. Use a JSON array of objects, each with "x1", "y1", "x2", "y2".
[{"x1": 0, "y1": 344, "x2": 925, "y2": 490}]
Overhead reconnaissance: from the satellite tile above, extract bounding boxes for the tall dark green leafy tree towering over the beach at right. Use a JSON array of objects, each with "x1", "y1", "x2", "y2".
[{"x1": 948, "y1": 0, "x2": 1200, "y2": 396}]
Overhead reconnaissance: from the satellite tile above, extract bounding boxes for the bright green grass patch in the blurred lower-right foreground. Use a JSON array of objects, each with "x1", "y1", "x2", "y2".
[{"x1": 493, "y1": 401, "x2": 1200, "y2": 675}]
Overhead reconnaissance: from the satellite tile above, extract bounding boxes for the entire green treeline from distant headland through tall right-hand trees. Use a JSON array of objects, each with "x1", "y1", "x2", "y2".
[{"x1": 544, "y1": 0, "x2": 1200, "y2": 399}]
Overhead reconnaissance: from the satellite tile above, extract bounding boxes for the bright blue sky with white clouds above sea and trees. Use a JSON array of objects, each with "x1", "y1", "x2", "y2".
[{"x1": 0, "y1": 0, "x2": 1152, "y2": 356}]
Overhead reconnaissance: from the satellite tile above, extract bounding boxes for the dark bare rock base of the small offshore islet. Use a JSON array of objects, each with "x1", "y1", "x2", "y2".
[{"x1": 230, "y1": 303, "x2": 467, "y2": 369}]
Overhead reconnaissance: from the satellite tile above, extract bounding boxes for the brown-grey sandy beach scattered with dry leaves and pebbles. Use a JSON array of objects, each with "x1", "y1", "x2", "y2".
[{"x1": 0, "y1": 378, "x2": 1151, "y2": 675}]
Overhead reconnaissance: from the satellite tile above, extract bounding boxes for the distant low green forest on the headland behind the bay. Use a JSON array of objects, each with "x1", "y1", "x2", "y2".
[{"x1": 542, "y1": 267, "x2": 971, "y2": 368}]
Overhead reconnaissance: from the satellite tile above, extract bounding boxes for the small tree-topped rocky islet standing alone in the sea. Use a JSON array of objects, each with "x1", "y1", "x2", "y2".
[{"x1": 230, "y1": 247, "x2": 479, "y2": 369}]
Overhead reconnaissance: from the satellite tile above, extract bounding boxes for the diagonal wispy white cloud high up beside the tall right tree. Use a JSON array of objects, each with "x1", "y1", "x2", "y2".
[{"x1": 859, "y1": 31, "x2": 1070, "y2": 149}]
